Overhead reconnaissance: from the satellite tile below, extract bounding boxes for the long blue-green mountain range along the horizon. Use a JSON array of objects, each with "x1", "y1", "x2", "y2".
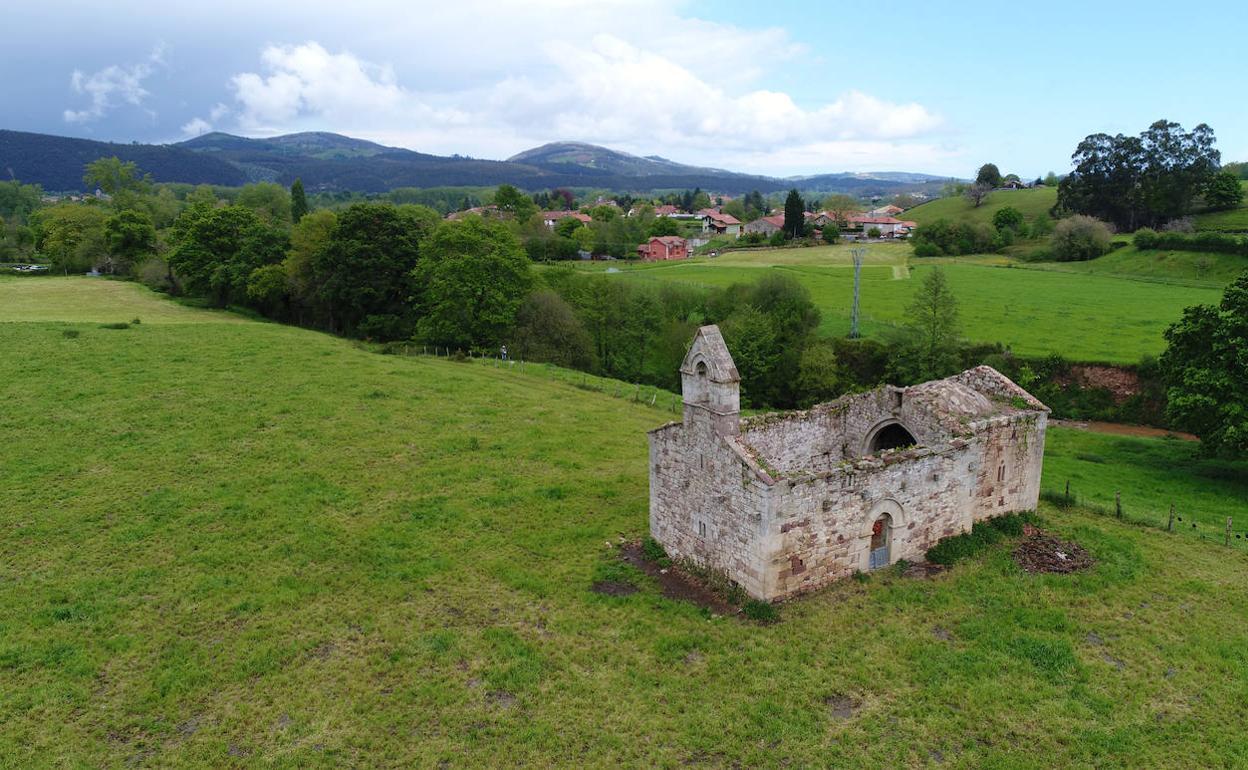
[{"x1": 0, "y1": 130, "x2": 947, "y2": 196}]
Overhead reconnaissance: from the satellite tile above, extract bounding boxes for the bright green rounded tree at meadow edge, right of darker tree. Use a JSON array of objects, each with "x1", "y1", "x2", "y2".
[{"x1": 412, "y1": 217, "x2": 533, "y2": 348}]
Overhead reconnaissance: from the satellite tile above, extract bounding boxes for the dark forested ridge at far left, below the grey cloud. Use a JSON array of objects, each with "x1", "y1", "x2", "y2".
[{"x1": 0, "y1": 130, "x2": 247, "y2": 192}]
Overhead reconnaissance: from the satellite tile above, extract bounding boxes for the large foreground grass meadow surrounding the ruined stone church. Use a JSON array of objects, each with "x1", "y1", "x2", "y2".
[{"x1": 7, "y1": 279, "x2": 1248, "y2": 768}]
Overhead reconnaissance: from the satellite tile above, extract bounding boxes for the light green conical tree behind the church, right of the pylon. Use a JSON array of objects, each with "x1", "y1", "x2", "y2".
[{"x1": 892, "y1": 267, "x2": 960, "y2": 382}]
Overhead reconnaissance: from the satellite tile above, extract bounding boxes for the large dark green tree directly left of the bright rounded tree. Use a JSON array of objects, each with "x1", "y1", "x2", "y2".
[{"x1": 312, "y1": 203, "x2": 439, "y2": 339}]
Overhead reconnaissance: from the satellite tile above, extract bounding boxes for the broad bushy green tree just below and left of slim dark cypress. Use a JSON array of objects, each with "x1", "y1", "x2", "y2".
[{"x1": 168, "y1": 206, "x2": 286, "y2": 307}]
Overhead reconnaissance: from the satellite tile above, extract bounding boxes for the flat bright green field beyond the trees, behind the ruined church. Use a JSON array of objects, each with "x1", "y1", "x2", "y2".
[{"x1": 574, "y1": 249, "x2": 1221, "y2": 363}]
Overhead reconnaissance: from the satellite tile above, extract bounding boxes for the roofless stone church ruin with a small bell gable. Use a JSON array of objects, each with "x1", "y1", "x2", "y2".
[{"x1": 649, "y1": 326, "x2": 1048, "y2": 599}]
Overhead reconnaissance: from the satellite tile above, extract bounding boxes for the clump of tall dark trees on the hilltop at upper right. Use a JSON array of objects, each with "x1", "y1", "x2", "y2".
[{"x1": 1057, "y1": 120, "x2": 1222, "y2": 231}]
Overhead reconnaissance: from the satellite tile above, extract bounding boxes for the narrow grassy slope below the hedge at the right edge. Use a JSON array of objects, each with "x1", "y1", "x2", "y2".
[{"x1": 1026, "y1": 246, "x2": 1248, "y2": 288}]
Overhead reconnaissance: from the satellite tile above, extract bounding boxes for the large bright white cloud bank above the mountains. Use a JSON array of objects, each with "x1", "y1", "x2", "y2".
[{"x1": 204, "y1": 0, "x2": 950, "y2": 173}]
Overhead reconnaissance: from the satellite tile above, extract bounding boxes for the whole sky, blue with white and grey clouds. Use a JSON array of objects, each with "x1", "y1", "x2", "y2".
[{"x1": 0, "y1": 0, "x2": 1248, "y2": 178}]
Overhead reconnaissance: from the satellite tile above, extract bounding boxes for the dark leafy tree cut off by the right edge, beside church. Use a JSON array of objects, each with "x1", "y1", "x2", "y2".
[{"x1": 1159, "y1": 272, "x2": 1248, "y2": 457}]
